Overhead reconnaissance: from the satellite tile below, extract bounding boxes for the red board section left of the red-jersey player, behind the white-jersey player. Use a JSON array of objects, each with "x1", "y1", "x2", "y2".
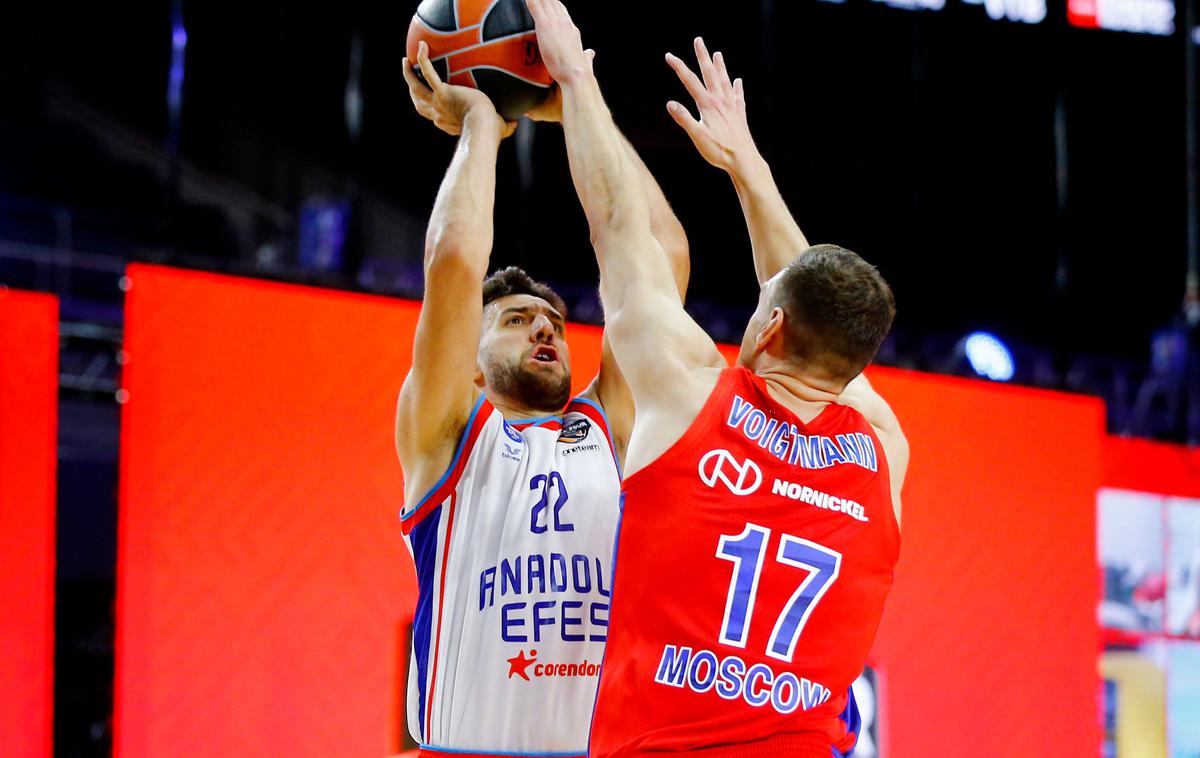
[{"x1": 115, "y1": 266, "x2": 599, "y2": 758}]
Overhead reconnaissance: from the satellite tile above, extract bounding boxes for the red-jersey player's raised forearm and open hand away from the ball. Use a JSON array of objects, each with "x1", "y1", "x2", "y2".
[{"x1": 667, "y1": 37, "x2": 809, "y2": 284}]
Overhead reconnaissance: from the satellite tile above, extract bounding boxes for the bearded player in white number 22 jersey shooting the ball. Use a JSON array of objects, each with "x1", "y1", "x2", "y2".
[{"x1": 396, "y1": 46, "x2": 688, "y2": 757}]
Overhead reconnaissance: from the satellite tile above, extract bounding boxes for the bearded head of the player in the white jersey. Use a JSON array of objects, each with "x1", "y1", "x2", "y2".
[{"x1": 475, "y1": 266, "x2": 571, "y2": 411}]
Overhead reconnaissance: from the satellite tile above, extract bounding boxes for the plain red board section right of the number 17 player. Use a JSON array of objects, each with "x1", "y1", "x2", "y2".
[{"x1": 871, "y1": 368, "x2": 1104, "y2": 758}]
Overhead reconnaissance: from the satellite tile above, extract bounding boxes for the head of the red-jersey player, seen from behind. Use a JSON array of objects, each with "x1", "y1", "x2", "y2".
[{"x1": 738, "y1": 245, "x2": 896, "y2": 385}]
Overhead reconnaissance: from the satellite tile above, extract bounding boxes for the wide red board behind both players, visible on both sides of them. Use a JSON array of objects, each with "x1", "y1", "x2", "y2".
[{"x1": 115, "y1": 266, "x2": 1103, "y2": 758}]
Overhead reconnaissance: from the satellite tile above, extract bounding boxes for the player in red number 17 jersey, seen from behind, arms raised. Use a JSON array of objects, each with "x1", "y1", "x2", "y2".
[{"x1": 528, "y1": 0, "x2": 908, "y2": 758}]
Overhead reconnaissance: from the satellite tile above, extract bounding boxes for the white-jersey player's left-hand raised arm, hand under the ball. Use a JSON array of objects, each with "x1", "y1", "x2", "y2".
[{"x1": 396, "y1": 42, "x2": 512, "y2": 499}]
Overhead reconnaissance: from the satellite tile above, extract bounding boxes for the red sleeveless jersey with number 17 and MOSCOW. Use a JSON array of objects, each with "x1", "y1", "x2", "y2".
[{"x1": 590, "y1": 367, "x2": 900, "y2": 758}]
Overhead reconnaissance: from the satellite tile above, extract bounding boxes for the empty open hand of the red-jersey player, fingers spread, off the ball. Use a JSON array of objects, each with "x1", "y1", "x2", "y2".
[{"x1": 667, "y1": 37, "x2": 757, "y2": 172}]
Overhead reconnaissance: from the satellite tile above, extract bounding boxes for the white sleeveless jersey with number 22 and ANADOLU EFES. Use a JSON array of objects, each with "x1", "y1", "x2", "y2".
[{"x1": 401, "y1": 397, "x2": 620, "y2": 756}]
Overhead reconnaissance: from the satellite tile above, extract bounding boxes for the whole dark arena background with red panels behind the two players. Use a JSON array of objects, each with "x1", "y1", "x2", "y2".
[{"x1": 0, "y1": 0, "x2": 1200, "y2": 758}]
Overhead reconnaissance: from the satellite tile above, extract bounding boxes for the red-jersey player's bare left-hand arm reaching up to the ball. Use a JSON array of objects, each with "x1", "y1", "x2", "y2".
[{"x1": 528, "y1": 0, "x2": 720, "y2": 458}]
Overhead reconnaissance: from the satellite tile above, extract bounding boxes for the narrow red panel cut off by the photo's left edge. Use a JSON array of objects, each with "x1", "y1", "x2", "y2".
[{"x1": 0, "y1": 287, "x2": 59, "y2": 758}]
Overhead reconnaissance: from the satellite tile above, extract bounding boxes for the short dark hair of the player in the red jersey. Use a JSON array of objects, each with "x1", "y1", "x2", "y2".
[{"x1": 773, "y1": 245, "x2": 896, "y2": 381}]
